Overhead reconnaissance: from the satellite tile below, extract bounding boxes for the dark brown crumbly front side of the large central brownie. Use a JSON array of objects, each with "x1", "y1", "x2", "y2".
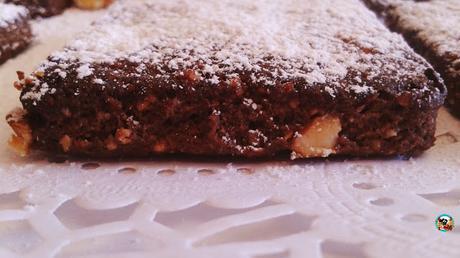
[{"x1": 15, "y1": 61, "x2": 445, "y2": 157}]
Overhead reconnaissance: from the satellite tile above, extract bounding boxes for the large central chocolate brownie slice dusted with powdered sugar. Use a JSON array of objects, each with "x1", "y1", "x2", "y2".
[{"x1": 7, "y1": 0, "x2": 446, "y2": 158}]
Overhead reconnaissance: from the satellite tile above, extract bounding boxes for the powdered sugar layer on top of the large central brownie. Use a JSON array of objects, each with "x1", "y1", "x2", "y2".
[{"x1": 24, "y1": 0, "x2": 426, "y2": 101}]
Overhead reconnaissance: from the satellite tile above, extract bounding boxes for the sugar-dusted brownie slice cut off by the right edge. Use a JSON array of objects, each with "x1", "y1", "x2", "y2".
[{"x1": 367, "y1": 0, "x2": 460, "y2": 115}]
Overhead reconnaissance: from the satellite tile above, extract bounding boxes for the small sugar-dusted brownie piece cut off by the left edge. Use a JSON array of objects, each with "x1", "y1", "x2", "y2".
[{"x1": 0, "y1": 3, "x2": 32, "y2": 64}]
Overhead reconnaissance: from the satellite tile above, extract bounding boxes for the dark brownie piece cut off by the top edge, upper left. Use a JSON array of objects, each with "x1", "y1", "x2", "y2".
[{"x1": 5, "y1": 0, "x2": 72, "y2": 17}]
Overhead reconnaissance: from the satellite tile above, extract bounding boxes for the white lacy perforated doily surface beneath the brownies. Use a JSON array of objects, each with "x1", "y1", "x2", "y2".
[{"x1": 0, "y1": 6, "x2": 460, "y2": 258}]
